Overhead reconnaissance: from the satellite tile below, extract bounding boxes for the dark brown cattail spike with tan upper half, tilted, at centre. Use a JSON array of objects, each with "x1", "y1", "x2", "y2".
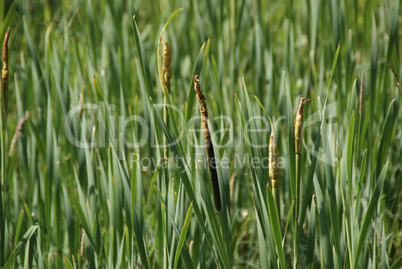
[{"x1": 194, "y1": 73, "x2": 221, "y2": 211}]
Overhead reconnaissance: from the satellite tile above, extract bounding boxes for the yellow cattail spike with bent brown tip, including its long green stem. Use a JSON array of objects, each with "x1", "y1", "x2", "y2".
[{"x1": 294, "y1": 97, "x2": 310, "y2": 265}]
